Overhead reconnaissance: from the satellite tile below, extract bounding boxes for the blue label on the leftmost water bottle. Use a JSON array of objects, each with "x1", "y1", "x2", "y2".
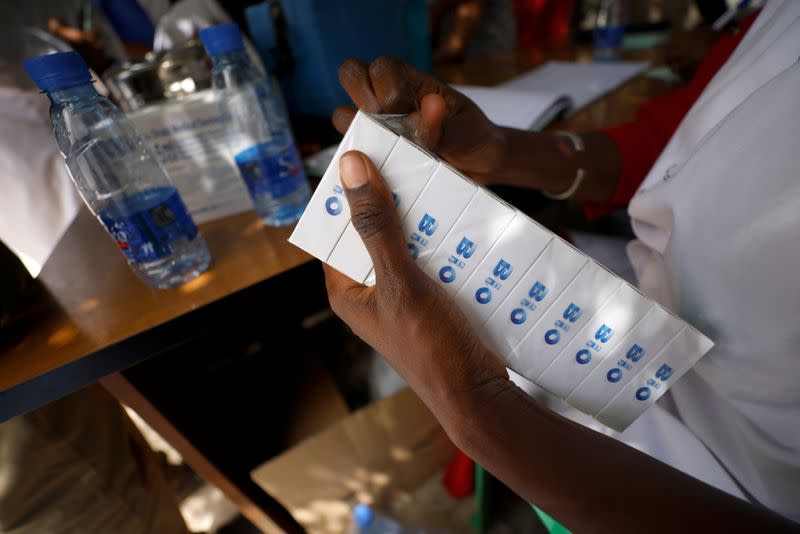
[{"x1": 99, "y1": 187, "x2": 197, "y2": 262}]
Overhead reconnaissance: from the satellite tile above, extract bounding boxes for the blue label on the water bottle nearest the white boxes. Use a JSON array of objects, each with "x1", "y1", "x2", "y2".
[{"x1": 235, "y1": 143, "x2": 306, "y2": 198}]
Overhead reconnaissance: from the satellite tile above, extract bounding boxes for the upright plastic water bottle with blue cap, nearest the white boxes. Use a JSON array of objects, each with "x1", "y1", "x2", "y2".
[{"x1": 200, "y1": 24, "x2": 311, "y2": 226}]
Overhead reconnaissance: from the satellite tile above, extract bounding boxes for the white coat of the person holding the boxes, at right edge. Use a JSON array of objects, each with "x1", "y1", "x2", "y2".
[{"x1": 621, "y1": 0, "x2": 800, "y2": 521}]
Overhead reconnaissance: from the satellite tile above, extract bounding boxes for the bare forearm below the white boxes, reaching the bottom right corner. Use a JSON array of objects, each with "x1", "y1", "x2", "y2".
[{"x1": 443, "y1": 380, "x2": 796, "y2": 532}]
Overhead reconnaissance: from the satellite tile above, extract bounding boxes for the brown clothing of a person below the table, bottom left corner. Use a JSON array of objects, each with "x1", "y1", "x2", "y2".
[{"x1": 0, "y1": 385, "x2": 189, "y2": 534}]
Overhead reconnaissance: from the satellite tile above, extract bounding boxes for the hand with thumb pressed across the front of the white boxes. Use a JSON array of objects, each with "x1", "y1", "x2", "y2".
[{"x1": 324, "y1": 151, "x2": 508, "y2": 418}]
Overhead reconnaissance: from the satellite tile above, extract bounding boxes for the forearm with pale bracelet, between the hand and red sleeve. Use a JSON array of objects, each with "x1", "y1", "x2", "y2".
[{"x1": 491, "y1": 128, "x2": 622, "y2": 202}]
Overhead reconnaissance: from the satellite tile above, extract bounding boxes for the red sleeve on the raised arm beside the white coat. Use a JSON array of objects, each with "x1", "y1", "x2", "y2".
[{"x1": 583, "y1": 14, "x2": 756, "y2": 219}]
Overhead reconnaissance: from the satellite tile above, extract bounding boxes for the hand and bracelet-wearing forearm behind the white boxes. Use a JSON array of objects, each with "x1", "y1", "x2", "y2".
[{"x1": 333, "y1": 57, "x2": 620, "y2": 201}]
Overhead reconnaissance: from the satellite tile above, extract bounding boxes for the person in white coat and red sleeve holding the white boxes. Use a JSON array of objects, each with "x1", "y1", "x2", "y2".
[{"x1": 324, "y1": 0, "x2": 800, "y2": 532}]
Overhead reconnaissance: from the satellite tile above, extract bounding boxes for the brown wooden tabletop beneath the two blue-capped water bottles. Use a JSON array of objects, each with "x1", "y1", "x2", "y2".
[{"x1": 0, "y1": 209, "x2": 311, "y2": 400}]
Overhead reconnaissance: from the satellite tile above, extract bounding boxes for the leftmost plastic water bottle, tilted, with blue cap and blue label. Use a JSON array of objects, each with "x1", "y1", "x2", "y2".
[{"x1": 24, "y1": 52, "x2": 211, "y2": 288}]
